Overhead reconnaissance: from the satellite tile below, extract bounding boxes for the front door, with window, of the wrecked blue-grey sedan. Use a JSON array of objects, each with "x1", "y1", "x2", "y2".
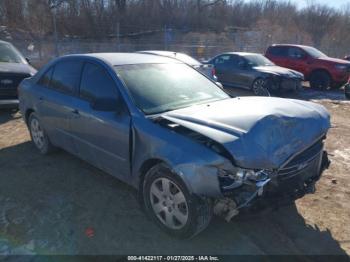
[{"x1": 70, "y1": 62, "x2": 130, "y2": 179}]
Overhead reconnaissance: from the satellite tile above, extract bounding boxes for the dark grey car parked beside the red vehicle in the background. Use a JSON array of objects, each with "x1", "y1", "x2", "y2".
[{"x1": 209, "y1": 52, "x2": 303, "y2": 95}]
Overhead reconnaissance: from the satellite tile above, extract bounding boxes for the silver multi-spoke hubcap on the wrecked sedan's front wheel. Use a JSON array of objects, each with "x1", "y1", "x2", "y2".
[{"x1": 150, "y1": 178, "x2": 188, "y2": 229}]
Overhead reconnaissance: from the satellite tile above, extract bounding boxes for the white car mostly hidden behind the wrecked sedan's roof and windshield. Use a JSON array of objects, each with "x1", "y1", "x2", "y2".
[{"x1": 138, "y1": 50, "x2": 218, "y2": 82}]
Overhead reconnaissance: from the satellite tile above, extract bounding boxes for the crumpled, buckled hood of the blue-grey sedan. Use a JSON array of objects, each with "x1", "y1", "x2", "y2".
[{"x1": 162, "y1": 97, "x2": 330, "y2": 169}]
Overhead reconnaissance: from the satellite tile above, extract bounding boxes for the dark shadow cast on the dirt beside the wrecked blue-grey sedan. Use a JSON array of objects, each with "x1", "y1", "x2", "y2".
[{"x1": 0, "y1": 142, "x2": 346, "y2": 255}]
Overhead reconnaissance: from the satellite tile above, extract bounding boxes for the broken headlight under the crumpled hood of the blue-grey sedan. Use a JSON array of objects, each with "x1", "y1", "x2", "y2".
[{"x1": 218, "y1": 168, "x2": 269, "y2": 191}]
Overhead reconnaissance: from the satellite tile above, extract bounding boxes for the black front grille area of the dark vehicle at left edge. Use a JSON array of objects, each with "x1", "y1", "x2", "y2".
[{"x1": 0, "y1": 73, "x2": 30, "y2": 99}]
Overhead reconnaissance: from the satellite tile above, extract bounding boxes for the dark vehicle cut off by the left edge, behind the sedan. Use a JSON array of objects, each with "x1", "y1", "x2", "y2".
[{"x1": 0, "y1": 41, "x2": 36, "y2": 108}]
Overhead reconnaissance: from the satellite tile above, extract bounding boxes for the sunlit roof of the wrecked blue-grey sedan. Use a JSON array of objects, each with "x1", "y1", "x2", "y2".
[{"x1": 60, "y1": 53, "x2": 181, "y2": 66}]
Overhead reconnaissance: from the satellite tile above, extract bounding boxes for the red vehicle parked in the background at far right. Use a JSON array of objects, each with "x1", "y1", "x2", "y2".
[{"x1": 265, "y1": 45, "x2": 350, "y2": 90}]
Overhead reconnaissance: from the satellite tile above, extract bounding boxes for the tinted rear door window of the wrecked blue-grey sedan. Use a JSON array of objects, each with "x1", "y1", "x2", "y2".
[{"x1": 50, "y1": 61, "x2": 83, "y2": 94}]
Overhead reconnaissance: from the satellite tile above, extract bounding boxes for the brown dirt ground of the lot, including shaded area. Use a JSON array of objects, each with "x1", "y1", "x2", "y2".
[{"x1": 0, "y1": 87, "x2": 350, "y2": 255}]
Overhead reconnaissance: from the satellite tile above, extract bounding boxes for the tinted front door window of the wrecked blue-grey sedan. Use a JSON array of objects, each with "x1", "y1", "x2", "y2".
[{"x1": 80, "y1": 63, "x2": 118, "y2": 101}]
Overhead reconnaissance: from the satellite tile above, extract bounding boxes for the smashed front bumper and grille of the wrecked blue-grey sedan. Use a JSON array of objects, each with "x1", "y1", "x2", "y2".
[{"x1": 214, "y1": 149, "x2": 330, "y2": 221}]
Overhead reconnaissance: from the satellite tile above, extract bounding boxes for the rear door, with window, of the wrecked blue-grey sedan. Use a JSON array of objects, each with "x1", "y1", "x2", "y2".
[{"x1": 36, "y1": 59, "x2": 83, "y2": 152}]
